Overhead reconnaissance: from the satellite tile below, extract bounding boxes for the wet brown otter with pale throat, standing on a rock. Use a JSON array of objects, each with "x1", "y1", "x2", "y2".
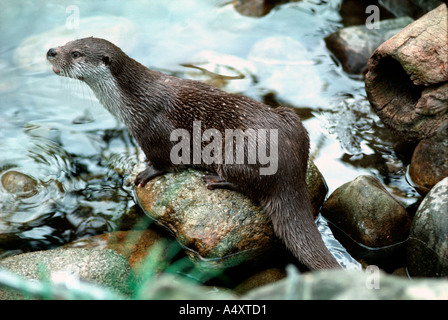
[{"x1": 47, "y1": 37, "x2": 341, "y2": 270}]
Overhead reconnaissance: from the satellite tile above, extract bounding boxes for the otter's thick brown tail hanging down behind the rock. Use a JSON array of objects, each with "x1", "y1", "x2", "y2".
[{"x1": 263, "y1": 183, "x2": 341, "y2": 270}]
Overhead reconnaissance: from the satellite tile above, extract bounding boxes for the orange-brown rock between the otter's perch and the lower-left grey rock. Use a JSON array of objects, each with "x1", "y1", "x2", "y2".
[{"x1": 64, "y1": 229, "x2": 165, "y2": 269}]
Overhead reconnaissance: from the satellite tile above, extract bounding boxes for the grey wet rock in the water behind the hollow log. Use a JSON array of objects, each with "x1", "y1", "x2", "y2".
[{"x1": 325, "y1": 17, "x2": 413, "y2": 75}]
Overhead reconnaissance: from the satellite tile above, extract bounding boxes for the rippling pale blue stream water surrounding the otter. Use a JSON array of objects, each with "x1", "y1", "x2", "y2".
[{"x1": 0, "y1": 0, "x2": 417, "y2": 256}]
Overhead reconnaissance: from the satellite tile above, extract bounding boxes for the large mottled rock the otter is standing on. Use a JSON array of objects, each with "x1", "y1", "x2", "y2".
[{"x1": 136, "y1": 160, "x2": 326, "y2": 266}]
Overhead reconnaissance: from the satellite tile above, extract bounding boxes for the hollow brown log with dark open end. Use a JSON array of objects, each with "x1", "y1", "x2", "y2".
[{"x1": 365, "y1": 4, "x2": 448, "y2": 141}]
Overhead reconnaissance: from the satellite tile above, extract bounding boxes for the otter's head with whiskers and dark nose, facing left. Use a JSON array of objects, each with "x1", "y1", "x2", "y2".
[{"x1": 47, "y1": 37, "x2": 124, "y2": 83}]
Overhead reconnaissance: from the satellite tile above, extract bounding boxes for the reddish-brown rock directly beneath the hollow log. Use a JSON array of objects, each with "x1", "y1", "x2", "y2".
[{"x1": 409, "y1": 122, "x2": 448, "y2": 194}]
